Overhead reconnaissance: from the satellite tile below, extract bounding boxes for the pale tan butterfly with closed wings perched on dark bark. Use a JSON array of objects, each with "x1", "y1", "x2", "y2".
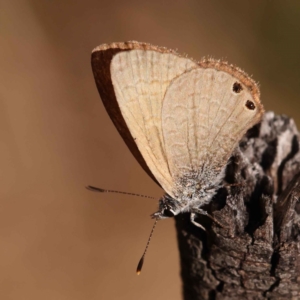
[{"x1": 92, "y1": 41, "x2": 264, "y2": 274}]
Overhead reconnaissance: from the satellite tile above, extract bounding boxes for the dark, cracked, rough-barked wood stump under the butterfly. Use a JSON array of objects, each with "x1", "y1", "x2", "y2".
[{"x1": 176, "y1": 112, "x2": 300, "y2": 300}]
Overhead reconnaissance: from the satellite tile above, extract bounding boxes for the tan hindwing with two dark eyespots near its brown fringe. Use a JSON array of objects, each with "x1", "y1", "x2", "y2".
[{"x1": 162, "y1": 61, "x2": 263, "y2": 188}]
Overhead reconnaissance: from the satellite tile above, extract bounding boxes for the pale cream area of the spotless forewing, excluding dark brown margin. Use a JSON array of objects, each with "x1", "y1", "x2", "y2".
[{"x1": 111, "y1": 50, "x2": 197, "y2": 195}]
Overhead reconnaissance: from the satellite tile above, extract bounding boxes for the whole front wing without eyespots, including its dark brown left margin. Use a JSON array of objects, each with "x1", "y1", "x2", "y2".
[{"x1": 92, "y1": 42, "x2": 198, "y2": 196}]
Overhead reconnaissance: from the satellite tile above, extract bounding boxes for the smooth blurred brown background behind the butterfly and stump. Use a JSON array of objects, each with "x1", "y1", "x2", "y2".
[{"x1": 0, "y1": 0, "x2": 300, "y2": 300}]
